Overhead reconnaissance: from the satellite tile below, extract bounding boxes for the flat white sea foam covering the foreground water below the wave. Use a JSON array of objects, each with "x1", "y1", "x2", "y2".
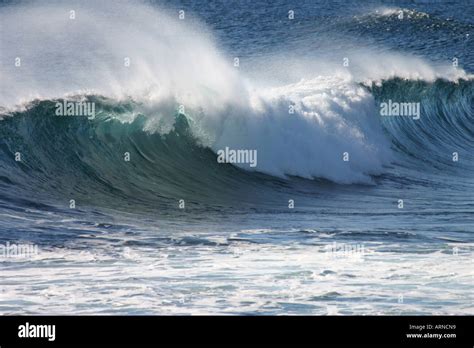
[{"x1": 0, "y1": 231, "x2": 473, "y2": 315}]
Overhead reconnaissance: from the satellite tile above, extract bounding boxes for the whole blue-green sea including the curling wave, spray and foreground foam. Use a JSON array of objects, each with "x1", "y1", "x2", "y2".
[{"x1": 0, "y1": 1, "x2": 474, "y2": 315}]
